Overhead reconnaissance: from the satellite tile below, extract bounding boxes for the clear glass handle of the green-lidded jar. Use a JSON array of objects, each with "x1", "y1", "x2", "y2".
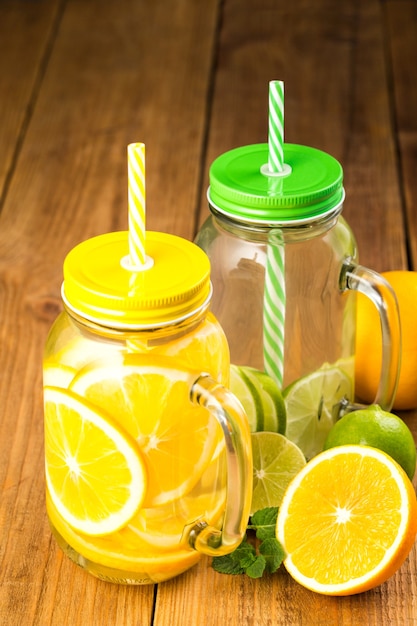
[{"x1": 342, "y1": 262, "x2": 401, "y2": 412}]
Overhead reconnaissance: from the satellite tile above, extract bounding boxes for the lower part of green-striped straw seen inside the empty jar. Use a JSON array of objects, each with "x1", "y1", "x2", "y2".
[{"x1": 263, "y1": 229, "x2": 286, "y2": 388}]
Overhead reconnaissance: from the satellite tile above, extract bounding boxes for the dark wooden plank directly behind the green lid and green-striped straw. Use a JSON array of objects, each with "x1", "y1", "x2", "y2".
[{"x1": 196, "y1": 0, "x2": 406, "y2": 271}]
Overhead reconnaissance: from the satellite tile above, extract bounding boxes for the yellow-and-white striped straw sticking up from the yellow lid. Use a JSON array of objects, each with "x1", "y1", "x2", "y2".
[{"x1": 127, "y1": 143, "x2": 146, "y2": 269}]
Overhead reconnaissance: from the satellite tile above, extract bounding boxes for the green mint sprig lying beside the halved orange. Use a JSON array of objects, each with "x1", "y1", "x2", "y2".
[{"x1": 212, "y1": 507, "x2": 285, "y2": 578}]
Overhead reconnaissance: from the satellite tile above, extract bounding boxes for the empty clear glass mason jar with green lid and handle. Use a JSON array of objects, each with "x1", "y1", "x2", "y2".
[{"x1": 196, "y1": 144, "x2": 400, "y2": 458}]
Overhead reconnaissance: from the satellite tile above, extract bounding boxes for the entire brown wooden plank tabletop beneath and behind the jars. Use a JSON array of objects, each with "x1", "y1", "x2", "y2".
[{"x1": 0, "y1": 0, "x2": 417, "y2": 626}]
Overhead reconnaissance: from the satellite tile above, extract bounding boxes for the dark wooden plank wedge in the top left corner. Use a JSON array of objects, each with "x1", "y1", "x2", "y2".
[{"x1": 0, "y1": 0, "x2": 62, "y2": 202}]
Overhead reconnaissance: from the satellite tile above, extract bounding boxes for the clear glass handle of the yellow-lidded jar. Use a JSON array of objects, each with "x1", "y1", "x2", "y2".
[{"x1": 188, "y1": 375, "x2": 252, "y2": 556}]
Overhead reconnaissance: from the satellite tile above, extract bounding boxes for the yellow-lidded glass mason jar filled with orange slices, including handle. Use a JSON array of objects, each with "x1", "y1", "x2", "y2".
[{"x1": 44, "y1": 233, "x2": 252, "y2": 584}]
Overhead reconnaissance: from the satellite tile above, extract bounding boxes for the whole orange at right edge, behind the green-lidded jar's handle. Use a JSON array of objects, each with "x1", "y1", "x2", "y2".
[{"x1": 355, "y1": 270, "x2": 417, "y2": 410}]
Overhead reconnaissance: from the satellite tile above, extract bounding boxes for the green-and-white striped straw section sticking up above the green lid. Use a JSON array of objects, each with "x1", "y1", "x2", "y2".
[{"x1": 268, "y1": 80, "x2": 284, "y2": 173}]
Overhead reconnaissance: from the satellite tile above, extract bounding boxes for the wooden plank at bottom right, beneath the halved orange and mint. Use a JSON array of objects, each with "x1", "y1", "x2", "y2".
[{"x1": 154, "y1": 540, "x2": 416, "y2": 626}]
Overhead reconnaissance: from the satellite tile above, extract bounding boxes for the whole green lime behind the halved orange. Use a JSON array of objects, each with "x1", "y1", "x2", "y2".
[{"x1": 324, "y1": 405, "x2": 416, "y2": 480}]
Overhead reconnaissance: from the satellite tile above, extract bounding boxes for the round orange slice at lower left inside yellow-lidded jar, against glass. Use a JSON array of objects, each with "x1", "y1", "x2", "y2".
[{"x1": 44, "y1": 387, "x2": 147, "y2": 535}]
